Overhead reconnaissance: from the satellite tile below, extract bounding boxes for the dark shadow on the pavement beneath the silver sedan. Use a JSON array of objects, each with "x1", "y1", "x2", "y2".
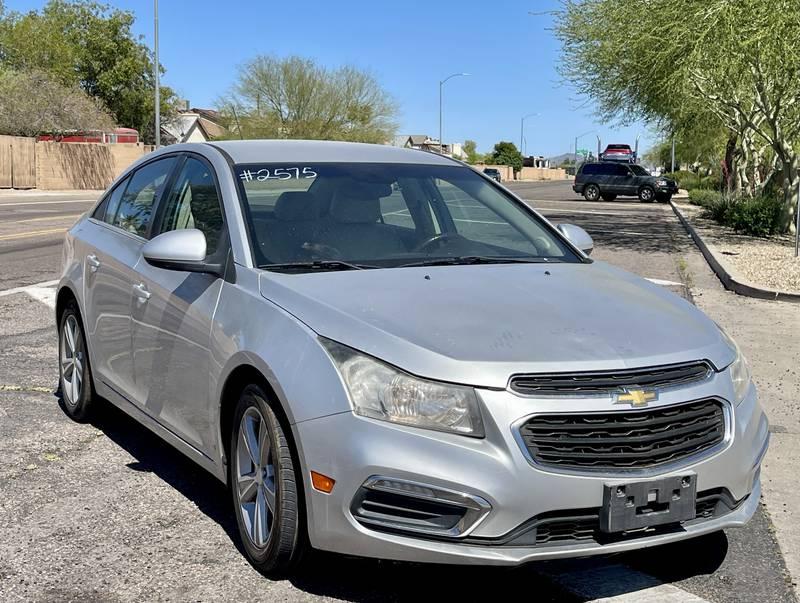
[{"x1": 69, "y1": 403, "x2": 752, "y2": 602}]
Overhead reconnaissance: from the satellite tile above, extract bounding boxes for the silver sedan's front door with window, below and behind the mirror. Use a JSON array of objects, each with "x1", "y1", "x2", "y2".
[{"x1": 132, "y1": 155, "x2": 230, "y2": 451}]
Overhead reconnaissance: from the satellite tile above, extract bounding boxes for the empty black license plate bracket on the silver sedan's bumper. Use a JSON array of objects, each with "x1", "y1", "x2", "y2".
[{"x1": 600, "y1": 474, "x2": 697, "y2": 534}]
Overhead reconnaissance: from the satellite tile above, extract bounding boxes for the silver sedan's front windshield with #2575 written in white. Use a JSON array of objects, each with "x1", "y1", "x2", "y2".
[{"x1": 234, "y1": 163, "x2": 582, "y2": 270}]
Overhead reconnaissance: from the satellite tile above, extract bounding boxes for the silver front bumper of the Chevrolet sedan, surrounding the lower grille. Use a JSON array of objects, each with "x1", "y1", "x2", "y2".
[{"x1": 295, "y1": 375, "x2": 769, "y2": 565}]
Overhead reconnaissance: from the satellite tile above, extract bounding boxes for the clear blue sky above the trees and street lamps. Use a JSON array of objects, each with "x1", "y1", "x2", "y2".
[{"x1": 6, "y1": 0, "x2": 654, "y2": 156}]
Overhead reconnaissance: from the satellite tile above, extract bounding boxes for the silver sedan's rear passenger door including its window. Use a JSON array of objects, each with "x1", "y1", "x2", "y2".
[{"x1": 81, "y1": 157, "x2": 175, "y2": 398}]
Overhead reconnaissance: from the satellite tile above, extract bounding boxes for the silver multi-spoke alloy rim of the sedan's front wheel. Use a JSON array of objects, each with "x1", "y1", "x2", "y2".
[{"x1": 235, "y1": 406, "x2": 276, "y2": 549}]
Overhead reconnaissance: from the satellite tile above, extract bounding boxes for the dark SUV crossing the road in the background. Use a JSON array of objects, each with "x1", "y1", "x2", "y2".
[{"x1": 572, "y1": 161, "x2": 678, "y2": 203}]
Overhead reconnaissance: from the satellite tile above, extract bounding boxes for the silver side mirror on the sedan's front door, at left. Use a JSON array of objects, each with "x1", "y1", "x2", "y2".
[{"x1": 142, "y1": 228, "x2": 222, "y2": 276}]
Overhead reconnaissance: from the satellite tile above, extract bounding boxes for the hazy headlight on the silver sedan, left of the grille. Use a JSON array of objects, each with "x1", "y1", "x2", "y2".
[{"x1": 320, "y1": 338, "x2": 484, "y2": 438}]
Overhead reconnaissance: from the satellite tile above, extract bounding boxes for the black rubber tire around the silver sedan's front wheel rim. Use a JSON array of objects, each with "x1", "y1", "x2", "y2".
[{"x1": 228, "y1": 385, "x2": 308, "y2": 578}]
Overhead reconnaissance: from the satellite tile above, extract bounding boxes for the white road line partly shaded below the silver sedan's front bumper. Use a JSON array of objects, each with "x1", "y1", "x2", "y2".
[{"x1": 548, "y1": 565, "x2": 708, "y2": 603}]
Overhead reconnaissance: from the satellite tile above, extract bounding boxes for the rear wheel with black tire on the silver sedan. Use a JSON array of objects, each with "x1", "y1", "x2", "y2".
[{"x1": 58, "y1": 301, "x2": 97, "y2": 422}]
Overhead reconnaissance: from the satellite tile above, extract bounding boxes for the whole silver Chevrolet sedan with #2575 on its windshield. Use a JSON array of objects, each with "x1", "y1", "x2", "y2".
[{"x1": 56, "y1": 141, "x2": 768, "y2": 575}]
